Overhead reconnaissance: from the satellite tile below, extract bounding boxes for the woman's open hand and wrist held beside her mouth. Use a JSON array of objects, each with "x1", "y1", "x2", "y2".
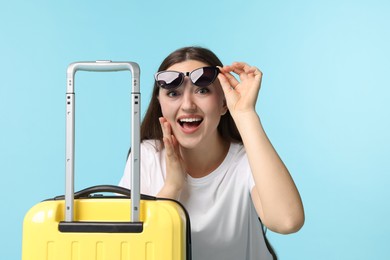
[{"x1": 157, "y1": 117, "x2": 186, "y2": 199}]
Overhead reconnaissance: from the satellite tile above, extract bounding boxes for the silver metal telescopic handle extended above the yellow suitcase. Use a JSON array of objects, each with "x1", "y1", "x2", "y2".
[{"x1": 65, "y1": 61, "x2": 141, "y2": 222}]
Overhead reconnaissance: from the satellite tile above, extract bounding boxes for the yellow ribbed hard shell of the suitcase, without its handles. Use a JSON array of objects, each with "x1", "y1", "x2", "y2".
[{"x1": 22, "y1": 198, "x2": 189, "y2": 260}]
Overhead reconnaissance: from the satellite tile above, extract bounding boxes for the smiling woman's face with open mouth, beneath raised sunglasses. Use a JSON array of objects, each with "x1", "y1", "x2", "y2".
[{"x1": 158, "y1": 60, "x2": 227, "y2": 149}]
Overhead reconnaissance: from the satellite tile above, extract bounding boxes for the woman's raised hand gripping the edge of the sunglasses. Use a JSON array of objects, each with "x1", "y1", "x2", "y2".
[{"x1": 218, "y1": 62, "x2": 263, "y2": 117}]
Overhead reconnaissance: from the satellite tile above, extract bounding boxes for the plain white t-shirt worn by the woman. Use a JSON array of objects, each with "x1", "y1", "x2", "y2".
[{"x1": 119, "y1": 140, "x2": 272, "y2": 260}]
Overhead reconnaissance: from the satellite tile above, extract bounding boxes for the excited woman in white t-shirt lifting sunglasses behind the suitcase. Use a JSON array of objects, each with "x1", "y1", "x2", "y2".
[{"x1": 120, "y1": 47, "x2": 304, "y2": 260}]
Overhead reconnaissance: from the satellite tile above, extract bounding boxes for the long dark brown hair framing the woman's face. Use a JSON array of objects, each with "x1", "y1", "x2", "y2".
[{"x1": 141, "y1": 47, "x2": 242, "y2": 146}]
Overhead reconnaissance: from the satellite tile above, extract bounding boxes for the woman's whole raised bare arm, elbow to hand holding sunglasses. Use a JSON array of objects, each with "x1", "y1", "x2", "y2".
[{"x1": 218, "y1": 62, "x2": 304, "y2": 234}]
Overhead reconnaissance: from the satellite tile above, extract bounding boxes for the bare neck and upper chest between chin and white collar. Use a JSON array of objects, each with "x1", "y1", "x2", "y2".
[{"x1": 180, "y1": 136, "x2": 230, "y2": 178}]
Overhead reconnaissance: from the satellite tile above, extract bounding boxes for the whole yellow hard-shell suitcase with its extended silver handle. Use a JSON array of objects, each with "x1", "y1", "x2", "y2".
[{"x1": 22, "y1": 61, "x2": 191, "y2": 260}]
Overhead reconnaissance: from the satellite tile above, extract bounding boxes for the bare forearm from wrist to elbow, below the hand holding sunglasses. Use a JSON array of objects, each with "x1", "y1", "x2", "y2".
[{"x1": 234, "y1": 111, "x2": 304, "y2": 233}]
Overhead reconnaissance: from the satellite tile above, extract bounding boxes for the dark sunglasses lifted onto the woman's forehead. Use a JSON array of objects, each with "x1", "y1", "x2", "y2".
[{"x1": 154, "y1": 67, "x2": 219, "y2": 90}]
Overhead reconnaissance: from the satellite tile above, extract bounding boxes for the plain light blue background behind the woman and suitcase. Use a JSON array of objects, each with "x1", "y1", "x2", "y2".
[{"x1": 0, "y1": 0, "x2": 390, "y2": 260}]
